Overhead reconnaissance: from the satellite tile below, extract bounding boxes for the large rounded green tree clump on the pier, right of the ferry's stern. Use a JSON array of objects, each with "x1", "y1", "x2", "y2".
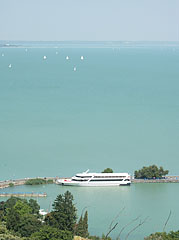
[{"x1": 134, "y1": 165, "x2": 169, "y2": 179}]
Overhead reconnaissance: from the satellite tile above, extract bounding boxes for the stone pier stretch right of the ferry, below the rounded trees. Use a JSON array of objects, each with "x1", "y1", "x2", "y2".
[{"x1": 131, "y1": 176, "x2": 179, "y2": 183}]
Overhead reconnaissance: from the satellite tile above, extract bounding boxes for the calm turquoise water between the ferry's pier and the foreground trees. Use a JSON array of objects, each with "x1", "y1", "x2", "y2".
[{"x1": 0, "y1": 183, "x2": 179, "y2": 240}]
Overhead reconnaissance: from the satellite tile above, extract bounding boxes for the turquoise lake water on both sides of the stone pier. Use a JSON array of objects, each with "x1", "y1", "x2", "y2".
[{"x1": 0, "y1": 46, "x2": 179, "y2": 239}]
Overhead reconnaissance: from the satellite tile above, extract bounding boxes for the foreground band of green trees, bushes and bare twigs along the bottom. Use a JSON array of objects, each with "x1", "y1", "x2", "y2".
[{"x1": 0, "y1": 191, "x2": 179, "y2": 240}]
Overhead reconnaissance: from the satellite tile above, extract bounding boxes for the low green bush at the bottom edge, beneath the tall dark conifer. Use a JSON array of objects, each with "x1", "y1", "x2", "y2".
[{"x1": 30, "y1": 226, "x2": 73, "y2": 240}]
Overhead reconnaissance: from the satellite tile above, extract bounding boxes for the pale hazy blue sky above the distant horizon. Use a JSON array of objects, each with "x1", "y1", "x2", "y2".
[{"x1": 0, "y1": 0, "x2": 179, "y2": 41}]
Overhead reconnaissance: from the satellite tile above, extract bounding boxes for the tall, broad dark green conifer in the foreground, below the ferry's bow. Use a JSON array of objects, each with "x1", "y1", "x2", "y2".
[{"x1": 45, "y1": 191, "x2": 77, "y2": 233}]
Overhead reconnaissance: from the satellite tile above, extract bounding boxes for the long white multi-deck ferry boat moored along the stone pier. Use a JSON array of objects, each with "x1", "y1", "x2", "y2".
[{"x1": 57, "y1": 170, "x2": 131, "y2": 187}]
